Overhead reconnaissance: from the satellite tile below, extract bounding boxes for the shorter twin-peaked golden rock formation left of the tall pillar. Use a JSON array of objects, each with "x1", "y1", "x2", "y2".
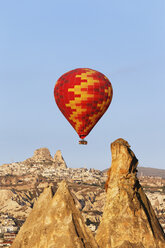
[{"x1": 11, "y1": 181, "x2": 98, "y2": 248}]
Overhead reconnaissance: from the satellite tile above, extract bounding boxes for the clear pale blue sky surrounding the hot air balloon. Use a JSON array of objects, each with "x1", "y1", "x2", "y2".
[{"x1": 0, "y1": 0, "x2": 165, "y2": 170}]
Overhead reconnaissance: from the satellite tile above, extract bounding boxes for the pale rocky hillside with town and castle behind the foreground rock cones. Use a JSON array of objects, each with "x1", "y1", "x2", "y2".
[{"x1": 0, "y1": 145, "x2": 165, "y2": 247}]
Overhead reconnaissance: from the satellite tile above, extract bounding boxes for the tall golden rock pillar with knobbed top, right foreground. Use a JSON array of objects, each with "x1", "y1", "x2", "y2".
[{"x1": 96, "y1": 139, "x2": 165, "y2": 248}]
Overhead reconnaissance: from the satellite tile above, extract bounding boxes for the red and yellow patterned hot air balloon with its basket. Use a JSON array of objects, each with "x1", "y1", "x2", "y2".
[{"x1": 54, "y1": 68, "x2": 113, "y2": 144}]
